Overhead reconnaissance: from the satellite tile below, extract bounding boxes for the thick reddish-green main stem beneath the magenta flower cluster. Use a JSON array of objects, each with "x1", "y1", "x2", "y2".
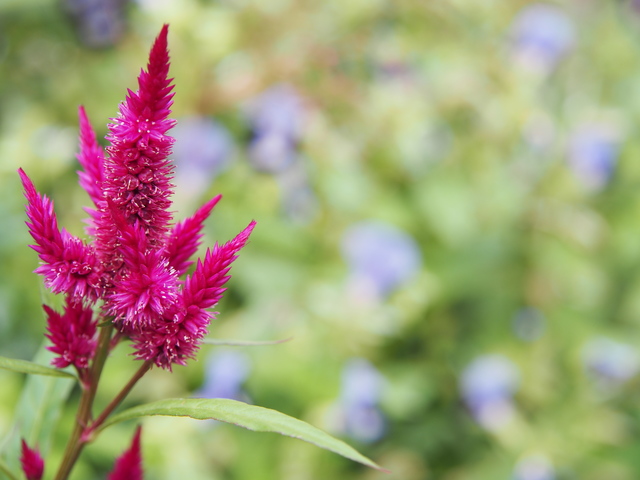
[{"x1": 55, "y1": 323, "x2": 113, "y2": 480}]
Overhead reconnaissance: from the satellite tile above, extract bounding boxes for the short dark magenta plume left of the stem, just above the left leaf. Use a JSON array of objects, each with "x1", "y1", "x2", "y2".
[{"x1": 42, "y1": 297, "x2": 97, "y2": 370}]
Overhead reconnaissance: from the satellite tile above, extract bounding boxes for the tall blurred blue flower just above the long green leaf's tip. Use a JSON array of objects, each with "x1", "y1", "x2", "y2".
[{"x1": 339, "y1": 358, "x2": 385, "y2": 442}]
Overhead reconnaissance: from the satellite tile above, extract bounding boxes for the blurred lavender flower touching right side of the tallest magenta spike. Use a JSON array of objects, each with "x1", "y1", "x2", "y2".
[{"x1": 171, "y1": 116, "x2": 235, "y2": 206}]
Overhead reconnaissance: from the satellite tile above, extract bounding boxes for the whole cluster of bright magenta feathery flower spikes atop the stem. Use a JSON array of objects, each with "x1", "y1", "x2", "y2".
[{"x1": 19, "y1": 25, "x2": 255, "y2": 370}]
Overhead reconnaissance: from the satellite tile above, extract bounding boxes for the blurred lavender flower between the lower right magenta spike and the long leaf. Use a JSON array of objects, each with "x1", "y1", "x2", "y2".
[{"x1": 194, "y1": 350, "x2": 251, "y2": 400}]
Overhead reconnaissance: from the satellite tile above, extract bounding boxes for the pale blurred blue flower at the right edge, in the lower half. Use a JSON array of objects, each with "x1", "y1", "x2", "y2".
[{"x1": 582, "y1": 337, "x2": 640, "y2": 391}]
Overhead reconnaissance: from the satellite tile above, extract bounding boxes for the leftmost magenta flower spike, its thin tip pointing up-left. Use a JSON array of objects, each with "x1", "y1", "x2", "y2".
[{"x1": 18, "y1": 169, "x2": 98, "y2": 301}]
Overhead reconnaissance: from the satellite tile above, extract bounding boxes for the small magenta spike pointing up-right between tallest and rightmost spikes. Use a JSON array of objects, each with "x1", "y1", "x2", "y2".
[{"x1": 164, "y1": 195, "x2": 222, "y2": 276}]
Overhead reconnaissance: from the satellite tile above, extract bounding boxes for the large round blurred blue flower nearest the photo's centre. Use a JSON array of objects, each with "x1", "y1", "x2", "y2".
[{"x1": 342, "y1": 221, "x2": 422, "y2": 298}]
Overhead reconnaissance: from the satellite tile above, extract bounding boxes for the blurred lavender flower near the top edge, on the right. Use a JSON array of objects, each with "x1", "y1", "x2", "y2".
[{"x1": 511, "y1": 3, "x2": 575, "y2": 73}]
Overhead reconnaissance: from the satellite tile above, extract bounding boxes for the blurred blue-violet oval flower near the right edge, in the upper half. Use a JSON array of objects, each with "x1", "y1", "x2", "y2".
[{"x1": 568, "y1": 124, "x2": 619, "y2": 190}]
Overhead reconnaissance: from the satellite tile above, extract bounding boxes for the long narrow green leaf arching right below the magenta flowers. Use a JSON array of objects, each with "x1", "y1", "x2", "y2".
[{"x1": 99, "y1": 398, "x2": 385, "y2": 471}]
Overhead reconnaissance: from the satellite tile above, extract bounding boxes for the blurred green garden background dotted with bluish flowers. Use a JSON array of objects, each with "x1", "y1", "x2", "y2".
[{"x1": 0, "y1": 0, "x2": 640, "y2": 480}]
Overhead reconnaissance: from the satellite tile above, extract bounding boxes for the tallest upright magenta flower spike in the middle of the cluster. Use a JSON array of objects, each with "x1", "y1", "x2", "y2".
[{"x1": 96, "y1": 25, "x2": 175, "y2": 255}]
